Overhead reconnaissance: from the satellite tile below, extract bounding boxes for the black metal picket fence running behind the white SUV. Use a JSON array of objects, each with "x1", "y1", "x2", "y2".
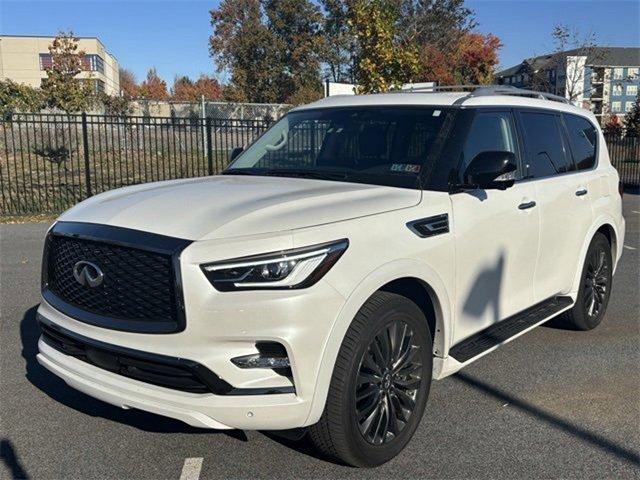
[{"x1": 0, "y1": 114, "x2": 640, "y2": 215}]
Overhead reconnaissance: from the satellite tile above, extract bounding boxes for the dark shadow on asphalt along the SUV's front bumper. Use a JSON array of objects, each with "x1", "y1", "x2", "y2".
[{"x1": 20, "y1": 305, "x2": 247, "y2": 441}]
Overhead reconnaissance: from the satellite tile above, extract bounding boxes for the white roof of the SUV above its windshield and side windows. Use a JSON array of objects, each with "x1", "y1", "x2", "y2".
[{"x1": 292, "y1": 92, "x2": 593, "y2": 117}]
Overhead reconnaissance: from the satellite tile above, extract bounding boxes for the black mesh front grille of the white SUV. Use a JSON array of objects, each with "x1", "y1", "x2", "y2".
[{"x1": 43, "y1": 224, "x2": 190, "y2": 333}]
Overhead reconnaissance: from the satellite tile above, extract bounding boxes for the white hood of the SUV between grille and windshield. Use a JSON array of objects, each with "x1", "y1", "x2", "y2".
[{"x1": 60, "y1": 175, "x2": 421, "y2": 240}]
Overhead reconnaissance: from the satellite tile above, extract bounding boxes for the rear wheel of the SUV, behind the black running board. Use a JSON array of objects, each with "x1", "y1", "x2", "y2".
[{"x1": 563, "y1": 232, "x2": 613, "y2": 330}]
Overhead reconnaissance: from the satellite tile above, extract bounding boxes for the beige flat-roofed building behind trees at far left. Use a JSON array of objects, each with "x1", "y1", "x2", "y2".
[{"x1": 0, "y1": 35, "x2": 120, "y2": 95}]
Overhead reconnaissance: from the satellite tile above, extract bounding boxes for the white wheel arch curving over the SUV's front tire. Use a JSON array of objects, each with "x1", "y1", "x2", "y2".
[{"x1": 305, "y1": 259, "x2": 451, "y2": 425}]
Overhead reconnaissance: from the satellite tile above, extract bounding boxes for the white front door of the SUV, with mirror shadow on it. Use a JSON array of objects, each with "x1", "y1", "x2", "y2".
[{"x1": 451, "y1": 110, "x2": 539, "y2": 344}]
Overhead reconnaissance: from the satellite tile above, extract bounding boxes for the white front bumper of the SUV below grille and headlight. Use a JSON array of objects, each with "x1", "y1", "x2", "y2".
[{"x1": 38, "y1": 268, "x2": 344, "y2": 430}]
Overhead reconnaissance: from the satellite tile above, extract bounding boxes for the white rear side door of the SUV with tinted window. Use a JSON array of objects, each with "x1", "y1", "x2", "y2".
[{"x1": 518, "y1": 109, "x2": 592, "y2": 302}]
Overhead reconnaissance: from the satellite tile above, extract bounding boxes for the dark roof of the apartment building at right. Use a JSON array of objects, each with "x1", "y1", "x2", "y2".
[{"x1": 496, "y1": 47, "x2": 640, "y2": 78}]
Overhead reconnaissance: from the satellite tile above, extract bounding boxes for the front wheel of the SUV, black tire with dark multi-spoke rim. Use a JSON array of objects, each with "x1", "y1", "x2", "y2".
[{"x1": 309, "y1": 292, "x2": 433, "y2": 467}]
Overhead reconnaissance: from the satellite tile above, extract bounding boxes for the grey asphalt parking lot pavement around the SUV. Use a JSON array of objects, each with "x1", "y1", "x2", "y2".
[{"x1": 0, "y1": 194, "x2": 640, "y2": 479}]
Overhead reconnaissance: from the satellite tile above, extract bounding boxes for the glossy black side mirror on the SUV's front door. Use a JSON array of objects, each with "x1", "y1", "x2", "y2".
[{"x1": 464, "y1": 151, "x2": 518, "y2": 190}]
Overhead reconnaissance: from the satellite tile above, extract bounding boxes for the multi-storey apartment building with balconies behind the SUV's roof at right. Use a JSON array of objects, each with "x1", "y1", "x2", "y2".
[{"x1": 496, "y1": 47, "x2": 640, "y2": 123}]
